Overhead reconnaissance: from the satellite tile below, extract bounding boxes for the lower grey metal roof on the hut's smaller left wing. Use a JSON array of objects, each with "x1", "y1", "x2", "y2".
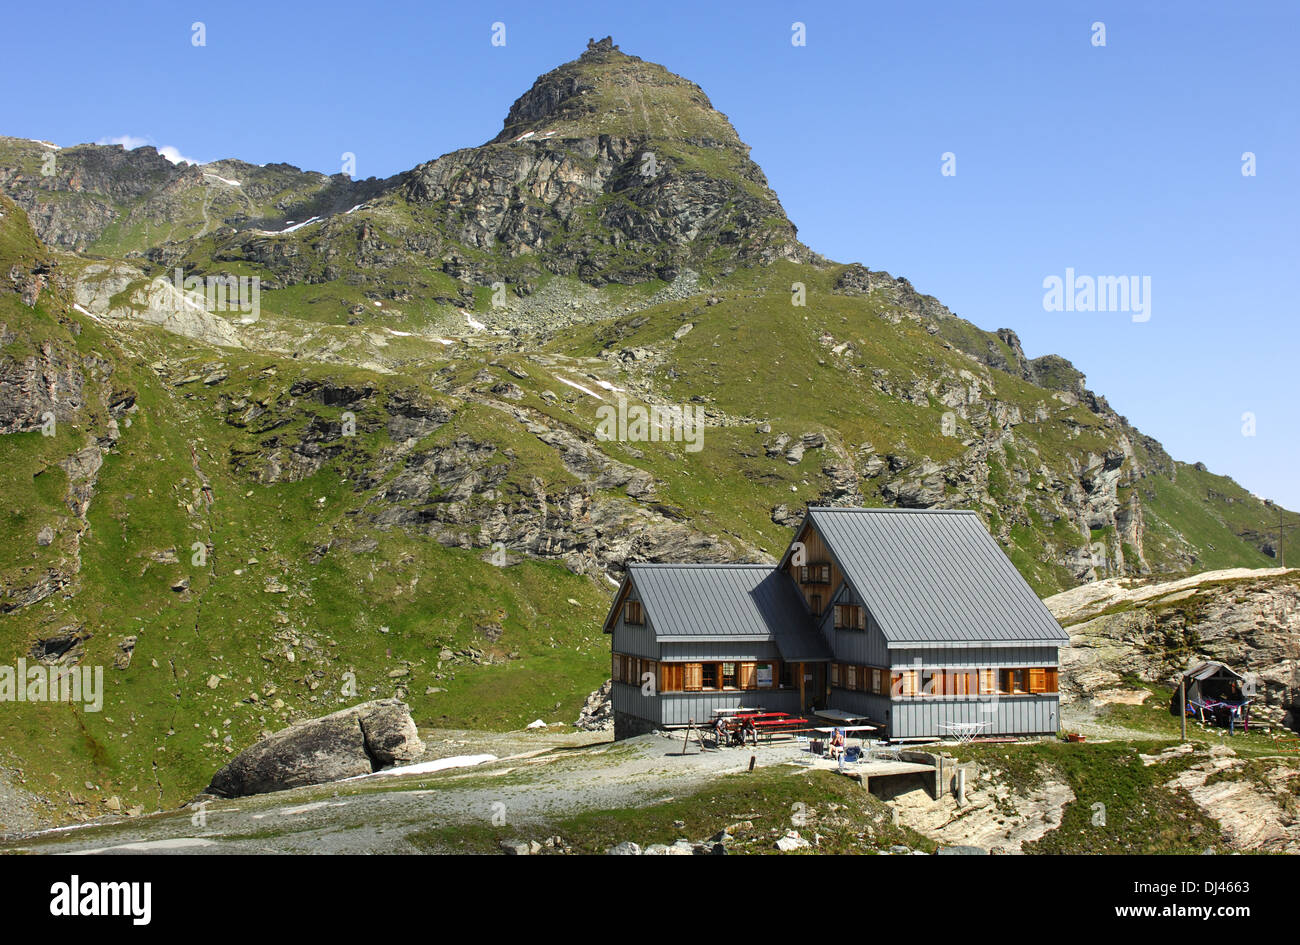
[{"x1": 628, "y1": 564, "x2": 831, "y2": 660}]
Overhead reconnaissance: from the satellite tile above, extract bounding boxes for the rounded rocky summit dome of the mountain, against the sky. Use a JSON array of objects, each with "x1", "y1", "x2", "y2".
[{"x1": 403, "y1": 40, "x2": 811, "y2": 285}]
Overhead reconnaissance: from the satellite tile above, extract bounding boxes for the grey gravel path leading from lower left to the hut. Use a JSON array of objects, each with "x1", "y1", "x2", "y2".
[{"x1": 0, "y1": 731, "x2": 800, "y2": 854}]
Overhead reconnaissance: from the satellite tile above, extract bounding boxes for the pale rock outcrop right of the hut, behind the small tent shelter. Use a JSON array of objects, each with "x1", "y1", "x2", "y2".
[{"x1": 1047, "y1": 568, "x2": 1300, "y2": 724}]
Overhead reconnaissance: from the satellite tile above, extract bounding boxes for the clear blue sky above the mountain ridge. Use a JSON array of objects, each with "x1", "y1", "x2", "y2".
[{"x1": 0, "y1": 0, "x2": 1300, "y2": 510}]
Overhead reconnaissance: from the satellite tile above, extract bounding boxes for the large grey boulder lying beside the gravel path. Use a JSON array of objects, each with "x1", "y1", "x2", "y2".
[{"x1": 207, "y1": 699, "x2": 424, "y2": 797}]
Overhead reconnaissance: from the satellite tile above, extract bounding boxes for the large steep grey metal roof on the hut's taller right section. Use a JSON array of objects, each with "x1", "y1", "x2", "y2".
[{"x1": 807, "y1": 507, "x2": 1070, "y2": 646}]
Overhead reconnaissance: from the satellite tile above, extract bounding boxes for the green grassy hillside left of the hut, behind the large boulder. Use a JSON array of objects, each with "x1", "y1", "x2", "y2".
[{"x1": 0, "y1": 219, "x2": 618, "y2": 814}]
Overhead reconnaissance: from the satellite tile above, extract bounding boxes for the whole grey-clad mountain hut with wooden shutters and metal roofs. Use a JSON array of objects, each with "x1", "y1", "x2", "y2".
[{"x1": 605, "y1": 507, "x2": 1069, "y2": 738}]
